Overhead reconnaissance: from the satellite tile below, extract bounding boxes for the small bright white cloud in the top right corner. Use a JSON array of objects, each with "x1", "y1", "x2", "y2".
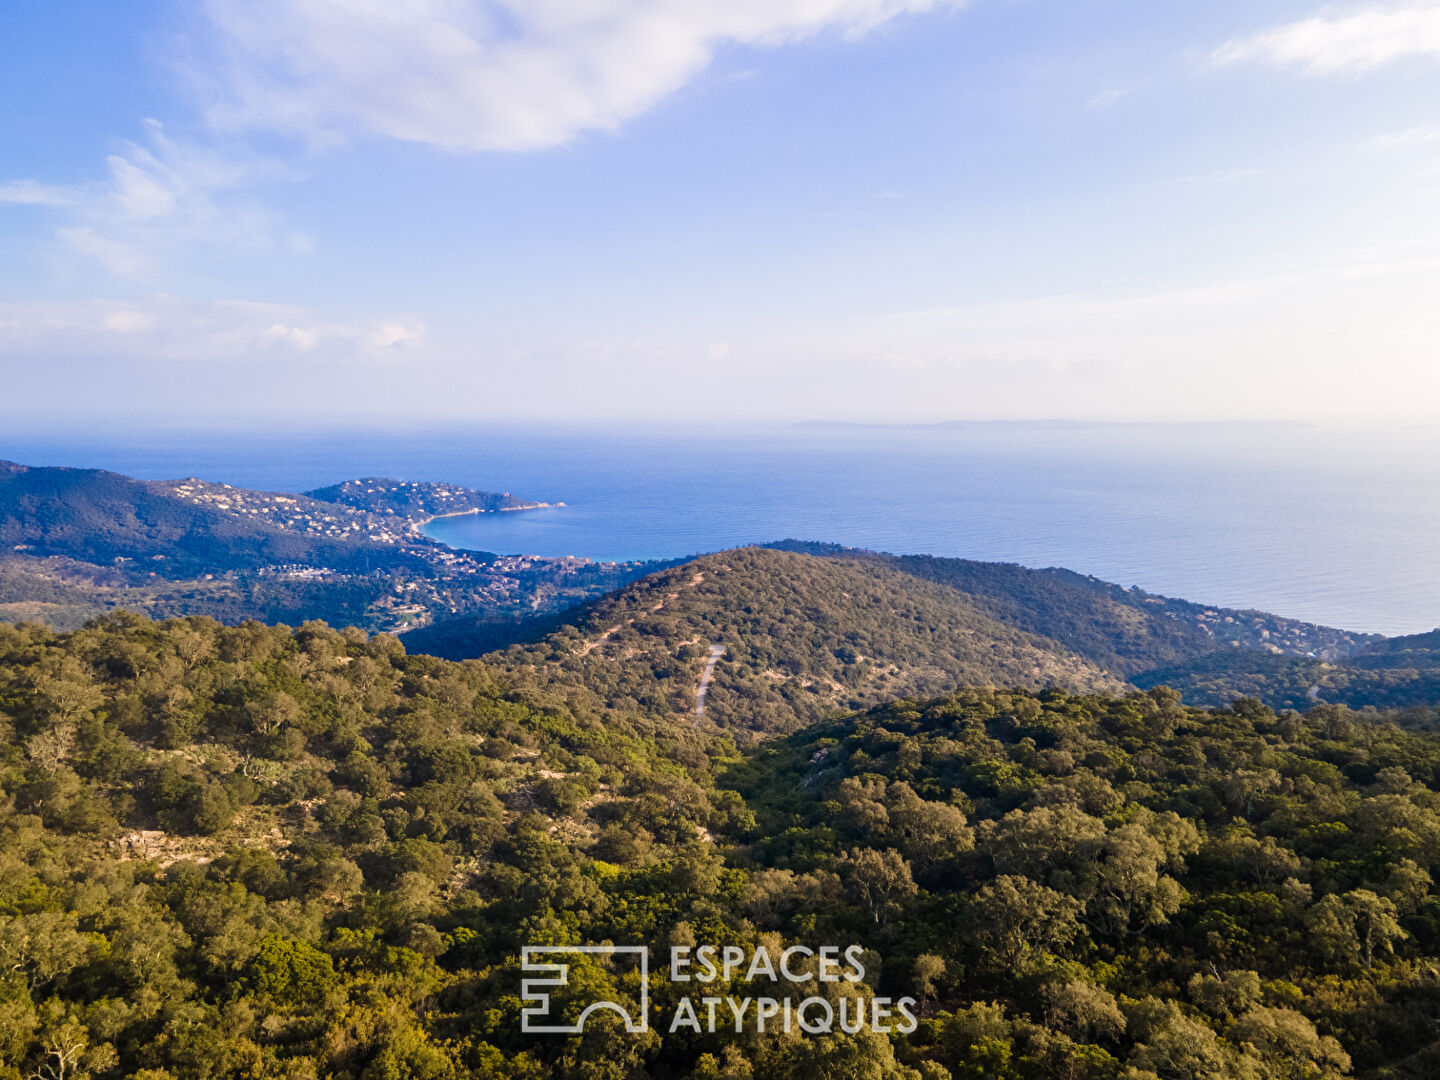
[{"x1": 1214, "y1": 1, "x2": 1440, "y2": 75}]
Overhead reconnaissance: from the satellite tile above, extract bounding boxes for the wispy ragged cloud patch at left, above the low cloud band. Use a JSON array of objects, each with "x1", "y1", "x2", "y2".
[{"x1": 0, "y1": 120, "x2": 304, "y2": 278}]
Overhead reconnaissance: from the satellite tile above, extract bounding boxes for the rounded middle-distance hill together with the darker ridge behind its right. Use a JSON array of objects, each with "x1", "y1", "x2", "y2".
[{"x1": 478, "y1": 541, "x2": 1388, "y2": 732}]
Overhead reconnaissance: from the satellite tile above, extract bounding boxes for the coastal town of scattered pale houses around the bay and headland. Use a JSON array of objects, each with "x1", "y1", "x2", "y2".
[{"x1": 0, "y1": 478, "x2": 641, "y2": 632}]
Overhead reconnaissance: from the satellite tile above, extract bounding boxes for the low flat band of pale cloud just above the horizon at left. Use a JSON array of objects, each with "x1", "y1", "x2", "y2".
[{"x1": 0, "y1": 297, "x2": 425, "y2": 363}]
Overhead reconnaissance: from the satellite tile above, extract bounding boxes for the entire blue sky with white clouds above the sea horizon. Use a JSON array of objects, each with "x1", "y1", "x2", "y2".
[{"x1": 0, "y1": 0, "x2": 1440, "y2": 428}]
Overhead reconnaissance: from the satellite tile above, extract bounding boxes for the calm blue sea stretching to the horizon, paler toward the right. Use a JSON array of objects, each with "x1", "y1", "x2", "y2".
[{"x1": 0, "y1": 426, "x2": 1440, "y2": 634}]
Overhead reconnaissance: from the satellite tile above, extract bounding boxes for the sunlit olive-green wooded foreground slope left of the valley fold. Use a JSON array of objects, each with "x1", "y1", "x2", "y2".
[{"x1": 0, "y1": 613, "x2": 732, "y2": 1080}]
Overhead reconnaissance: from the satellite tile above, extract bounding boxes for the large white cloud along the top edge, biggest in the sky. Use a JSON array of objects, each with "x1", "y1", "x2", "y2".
[{"x1": 192, "y1": 0, "x2": 962, "y2": 150}]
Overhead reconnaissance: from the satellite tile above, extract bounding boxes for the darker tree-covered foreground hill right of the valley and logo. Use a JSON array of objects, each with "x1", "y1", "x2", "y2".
[{"x1": 721, "y1": 690, "x2": 1440, "y2": 1080}]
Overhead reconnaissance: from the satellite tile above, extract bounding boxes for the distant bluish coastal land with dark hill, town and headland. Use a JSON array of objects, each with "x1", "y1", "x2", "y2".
[{"x1": 0, "y1": 462, "x2": 648, "y2": 641}]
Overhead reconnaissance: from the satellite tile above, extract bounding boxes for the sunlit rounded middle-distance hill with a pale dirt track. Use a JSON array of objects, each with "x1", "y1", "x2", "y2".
[{"x1": 492, "y1": 547, "x2": 1123, "y2": 732}]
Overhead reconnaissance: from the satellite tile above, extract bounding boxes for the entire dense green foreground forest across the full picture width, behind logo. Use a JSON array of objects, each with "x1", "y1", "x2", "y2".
[{"x1": 0, "y1": 613, "x2": 1440, "y2": 1080}]
